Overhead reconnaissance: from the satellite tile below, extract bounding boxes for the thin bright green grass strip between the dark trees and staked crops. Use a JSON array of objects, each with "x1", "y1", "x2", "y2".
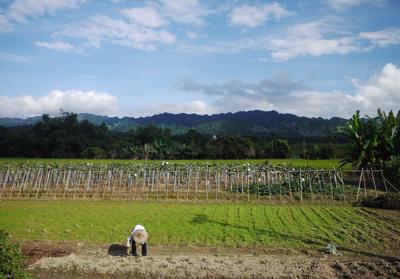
[{"x1": 0, "y1": 158, "x2": 351, "y2": 169}]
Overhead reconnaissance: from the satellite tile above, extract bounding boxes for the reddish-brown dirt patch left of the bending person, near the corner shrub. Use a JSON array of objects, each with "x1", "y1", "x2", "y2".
[{"x1": 22, "y1": 242, "x2": 75, "y2": 265}]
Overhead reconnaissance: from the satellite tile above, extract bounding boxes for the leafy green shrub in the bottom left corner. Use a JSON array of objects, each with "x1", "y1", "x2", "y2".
[{"x1": 0, "y1": 230, "x2": 32, "y2": 278}]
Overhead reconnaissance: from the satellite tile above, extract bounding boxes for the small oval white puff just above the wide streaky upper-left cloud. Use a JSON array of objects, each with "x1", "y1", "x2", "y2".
[{"x1": 121, "y1": 7, "x2": 166, "y2": 28}]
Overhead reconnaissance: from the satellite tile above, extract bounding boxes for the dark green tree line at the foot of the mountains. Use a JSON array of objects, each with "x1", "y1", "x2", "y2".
[{"x1": 0, "y1": 113, "x2": 345, "y2": 159}]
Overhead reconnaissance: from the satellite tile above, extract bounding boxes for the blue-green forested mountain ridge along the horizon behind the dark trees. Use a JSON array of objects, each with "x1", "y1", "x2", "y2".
[{"x1": 0, "y1": 110, "x2": 346, "y2": 138}]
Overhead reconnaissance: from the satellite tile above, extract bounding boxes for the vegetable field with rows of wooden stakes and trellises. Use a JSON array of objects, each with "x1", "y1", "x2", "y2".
[{"x1": 0, "y1": 162, "x2": 398, "y2": 201}]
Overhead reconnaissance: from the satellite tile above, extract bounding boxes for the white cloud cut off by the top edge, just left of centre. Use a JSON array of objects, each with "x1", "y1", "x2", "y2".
[{"x1": 161, "y1": 0, "x2": 208, "y2": 25}]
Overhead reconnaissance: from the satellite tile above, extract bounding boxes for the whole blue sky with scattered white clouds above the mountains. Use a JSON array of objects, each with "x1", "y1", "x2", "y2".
[{"x1": 0, "y1": 0, "x2": 400, "y2": 118}]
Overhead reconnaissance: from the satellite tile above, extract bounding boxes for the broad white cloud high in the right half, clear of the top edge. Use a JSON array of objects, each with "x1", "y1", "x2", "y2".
[{"x1": 264, "y1": 20, "x2": 362, "y2": 61}]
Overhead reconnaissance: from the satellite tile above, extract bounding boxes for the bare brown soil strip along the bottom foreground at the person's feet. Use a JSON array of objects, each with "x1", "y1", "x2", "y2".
[{"x1": 23, "y1": 243, "x2": 400, "y2": 278}]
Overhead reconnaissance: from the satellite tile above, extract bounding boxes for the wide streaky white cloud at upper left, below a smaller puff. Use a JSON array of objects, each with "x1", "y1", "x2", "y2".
[{"x1": 62, "y1": 15, "x2": 176, "y2": 51}]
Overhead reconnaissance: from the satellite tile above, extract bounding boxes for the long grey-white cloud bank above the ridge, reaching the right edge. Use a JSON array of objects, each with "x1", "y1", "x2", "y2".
[{"x1": 177, "y1": 63, "x2": 400, "y2": 117}]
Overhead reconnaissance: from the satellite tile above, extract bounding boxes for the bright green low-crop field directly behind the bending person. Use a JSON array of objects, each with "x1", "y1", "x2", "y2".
[{"x1": 0, "y1": 201, "x2": 400, "y2": 252}]
